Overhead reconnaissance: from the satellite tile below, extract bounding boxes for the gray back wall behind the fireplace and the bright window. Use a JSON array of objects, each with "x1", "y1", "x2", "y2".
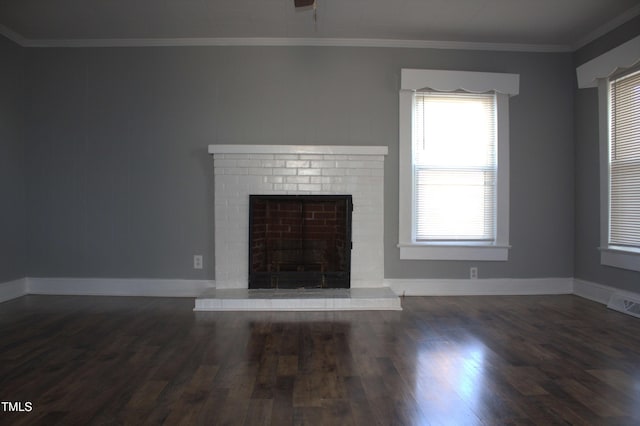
[{"x1": 26, "y1": 47, "x2": 574, "y2": 279}]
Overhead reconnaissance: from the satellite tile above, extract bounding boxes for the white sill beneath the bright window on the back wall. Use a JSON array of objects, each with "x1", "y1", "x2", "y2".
[{"x1": 398, "y1": 243, "x2": 510, "y2": 261}]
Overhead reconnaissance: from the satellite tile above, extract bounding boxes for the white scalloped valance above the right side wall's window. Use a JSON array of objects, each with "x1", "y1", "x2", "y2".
[{"x1": 576, "y1": 36, "x2": 640, "y2": 89}]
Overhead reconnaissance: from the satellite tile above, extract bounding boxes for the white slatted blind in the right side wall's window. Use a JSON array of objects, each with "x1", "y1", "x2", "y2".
[{"x1": 609, "y1": 71, "x2": 640, "y2": 248}]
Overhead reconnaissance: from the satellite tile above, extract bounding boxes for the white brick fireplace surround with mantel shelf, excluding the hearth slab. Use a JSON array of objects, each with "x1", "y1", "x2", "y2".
[{"x1": 209, "y1": 144, "x2": 388, "y2": 289}]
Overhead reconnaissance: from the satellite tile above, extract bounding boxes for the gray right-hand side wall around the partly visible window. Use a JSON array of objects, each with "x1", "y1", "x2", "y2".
[{"x1": 574, "y1": 20, "x2": 640, "y2": 292}]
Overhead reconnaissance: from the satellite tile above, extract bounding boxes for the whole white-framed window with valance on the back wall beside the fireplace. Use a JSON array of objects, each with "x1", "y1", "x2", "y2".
[{"x1": 398, "y1": 70, "x2": 518, "y2": 260}]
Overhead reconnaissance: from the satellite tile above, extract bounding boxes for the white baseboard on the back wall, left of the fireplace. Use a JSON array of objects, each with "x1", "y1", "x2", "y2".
[{"x1": 27, "y1": 278, "x2": 215, "y2": 297}]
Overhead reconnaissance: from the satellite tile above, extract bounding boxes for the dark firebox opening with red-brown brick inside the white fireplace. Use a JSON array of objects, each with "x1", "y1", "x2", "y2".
[{"x1": 249, "y1": 195, "x2": 353, "y2": 289}]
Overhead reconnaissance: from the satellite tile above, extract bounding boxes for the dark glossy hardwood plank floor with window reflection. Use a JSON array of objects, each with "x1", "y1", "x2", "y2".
[{"x1": 0, "y1": 296, "x2": 640, "y2": 425}]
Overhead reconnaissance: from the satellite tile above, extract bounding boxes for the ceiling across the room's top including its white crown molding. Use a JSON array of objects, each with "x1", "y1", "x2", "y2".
[{"x1": 0, "y1": 0, "x2": 640, "y2": 50}]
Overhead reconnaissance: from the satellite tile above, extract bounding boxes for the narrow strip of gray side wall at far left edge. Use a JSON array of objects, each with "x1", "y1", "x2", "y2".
[{"x1": 0, "y1": 36, "x2": 27, "y2": 283}]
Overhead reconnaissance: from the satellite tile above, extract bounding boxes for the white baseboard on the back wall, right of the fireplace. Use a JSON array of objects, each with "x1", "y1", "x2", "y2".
[{"x1": 385, "y1": 278, "x2": 573, "y2": 296}]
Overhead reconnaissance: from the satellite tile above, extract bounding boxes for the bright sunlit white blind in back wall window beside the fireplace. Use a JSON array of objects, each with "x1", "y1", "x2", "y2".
[{"x1": 412, "y1": 92, "x2": 497, "y2": 242}]
